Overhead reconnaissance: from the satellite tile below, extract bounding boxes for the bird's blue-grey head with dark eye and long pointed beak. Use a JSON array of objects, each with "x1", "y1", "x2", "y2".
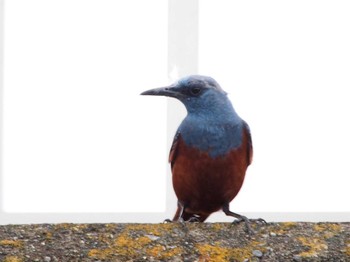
[{"x1": 141, "y1": 75, "x2": 231, "y2": 113}]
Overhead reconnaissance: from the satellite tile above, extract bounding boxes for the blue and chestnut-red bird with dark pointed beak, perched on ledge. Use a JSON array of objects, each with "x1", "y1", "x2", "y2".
[{"x1": 141, "y1": 75, "x2": 262, "y2": 233}]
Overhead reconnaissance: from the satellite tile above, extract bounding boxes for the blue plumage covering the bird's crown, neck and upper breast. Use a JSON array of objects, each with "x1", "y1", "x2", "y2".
[{"x1": 177, "y1": 79, "x2": 243, "y2": 157}]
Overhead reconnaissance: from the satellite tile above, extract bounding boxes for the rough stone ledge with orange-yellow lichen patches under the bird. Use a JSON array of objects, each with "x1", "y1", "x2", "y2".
[{"x1": 0, "y1": 222, "x2": 350, "y2": 262}]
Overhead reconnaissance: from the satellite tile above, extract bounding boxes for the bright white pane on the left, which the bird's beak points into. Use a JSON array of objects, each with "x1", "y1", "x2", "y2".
[{"x1": 3, "y1": 0, "x2": 168, "y2": 212}]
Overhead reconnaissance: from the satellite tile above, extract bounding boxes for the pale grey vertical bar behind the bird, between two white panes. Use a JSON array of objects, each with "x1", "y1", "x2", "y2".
[{"x1": 166, "y1": 0, "x2": 198, "y2": 217}]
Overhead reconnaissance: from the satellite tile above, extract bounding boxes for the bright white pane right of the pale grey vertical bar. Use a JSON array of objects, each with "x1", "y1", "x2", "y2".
[{"x1": 199, "y1": 0, "x2": 350, "y2": 212}]
